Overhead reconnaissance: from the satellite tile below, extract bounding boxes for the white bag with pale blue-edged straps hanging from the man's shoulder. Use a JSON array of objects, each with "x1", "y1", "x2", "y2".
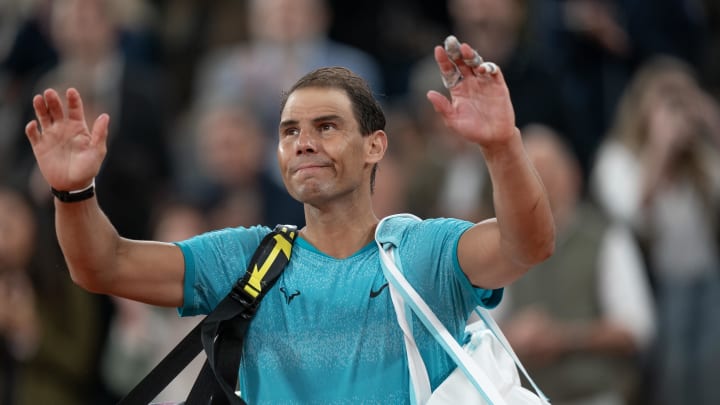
[{"x1": 375, "y1": 214, "x2": 549, "y2": 405}]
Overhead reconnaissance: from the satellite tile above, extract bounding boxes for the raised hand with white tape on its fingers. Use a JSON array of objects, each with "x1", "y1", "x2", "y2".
[{"x1": 427, "y1": 36, "x2": 517, "y2": 147}]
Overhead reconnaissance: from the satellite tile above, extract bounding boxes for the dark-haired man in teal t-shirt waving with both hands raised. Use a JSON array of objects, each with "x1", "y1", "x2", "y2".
[{"x1": 21, "y1": 37, "x2": 554, "y2": 404}]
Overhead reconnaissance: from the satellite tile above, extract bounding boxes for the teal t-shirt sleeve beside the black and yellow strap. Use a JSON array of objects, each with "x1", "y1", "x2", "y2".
[{"x1": 176, "y1": 226, "x2": 270, "y2": 316}]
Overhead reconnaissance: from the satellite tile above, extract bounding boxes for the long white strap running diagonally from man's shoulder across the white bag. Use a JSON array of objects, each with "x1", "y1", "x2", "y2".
[{"x1": 377, "y1": 242, "x2": 506, "y2": 405}]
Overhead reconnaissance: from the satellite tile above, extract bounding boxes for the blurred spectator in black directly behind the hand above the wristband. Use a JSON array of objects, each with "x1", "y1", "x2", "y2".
[{"x1": 18, "y1": 0, "x2": 170, "y2": 237}]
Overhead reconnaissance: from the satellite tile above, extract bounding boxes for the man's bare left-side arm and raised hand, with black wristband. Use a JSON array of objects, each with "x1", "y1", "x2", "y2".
[{"x1": 25, "y1": 88, "x2": 185, "y2": 307}]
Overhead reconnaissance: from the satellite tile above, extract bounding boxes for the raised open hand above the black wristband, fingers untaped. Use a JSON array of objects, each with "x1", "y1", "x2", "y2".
[{"x1": 25, "y1": 88, "x2": 110, "y2": 191}]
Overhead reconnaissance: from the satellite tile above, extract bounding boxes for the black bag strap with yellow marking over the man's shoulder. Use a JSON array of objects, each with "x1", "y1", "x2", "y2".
[{"x1": 118, "y1": 225, "x2": 297, "y2": 405}]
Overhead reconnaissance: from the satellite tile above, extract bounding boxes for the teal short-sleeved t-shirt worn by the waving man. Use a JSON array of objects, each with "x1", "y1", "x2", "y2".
[{"x1": 178, "y1": 219, "x2": 502, "y2": 405}]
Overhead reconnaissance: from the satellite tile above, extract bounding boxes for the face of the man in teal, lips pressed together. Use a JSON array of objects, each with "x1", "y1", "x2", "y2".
[{"x1": 278, "y1": 87, "x2": 374, "y2": 206}]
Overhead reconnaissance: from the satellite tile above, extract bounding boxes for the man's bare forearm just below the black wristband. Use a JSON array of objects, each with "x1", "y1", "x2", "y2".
[{"x1": 55, "y1": 197, "x2": 120, "y2": 292}]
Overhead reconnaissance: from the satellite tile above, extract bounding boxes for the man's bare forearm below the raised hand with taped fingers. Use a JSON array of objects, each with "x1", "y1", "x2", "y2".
[{"x1": 482, "y1": 129, "x2": 555, "y2": 267}]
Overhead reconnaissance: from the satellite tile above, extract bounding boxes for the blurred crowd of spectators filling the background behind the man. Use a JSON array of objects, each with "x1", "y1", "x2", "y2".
[{"x1": 0, "y1": 0, "x2": 720, "y2": 405}]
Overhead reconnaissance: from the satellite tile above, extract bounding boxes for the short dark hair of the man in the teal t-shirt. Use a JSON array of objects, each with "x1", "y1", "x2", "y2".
[{"x1": 280, "y1": 66, "x2": 385, "y2": 192}]
